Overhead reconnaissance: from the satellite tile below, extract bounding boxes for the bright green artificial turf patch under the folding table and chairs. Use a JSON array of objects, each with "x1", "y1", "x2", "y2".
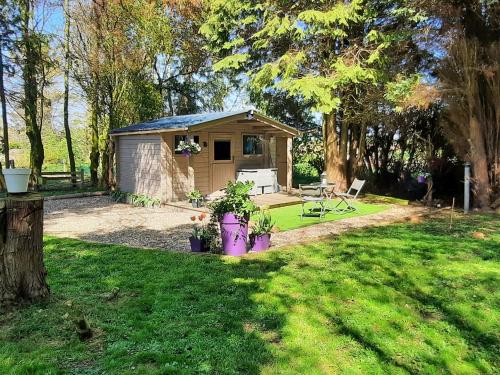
[{"x1": 258, "y1": 200, "x2": 389, "y2": 231}]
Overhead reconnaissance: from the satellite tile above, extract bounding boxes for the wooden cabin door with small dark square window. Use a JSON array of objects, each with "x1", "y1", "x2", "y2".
[{"x1": 210, "y1": 133, "x2": 235, "y2": 192}]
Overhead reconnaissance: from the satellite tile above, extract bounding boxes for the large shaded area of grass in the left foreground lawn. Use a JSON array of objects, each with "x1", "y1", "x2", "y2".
[{"x1": 0, "y1": 238, "x2": 290, "y2": 374}]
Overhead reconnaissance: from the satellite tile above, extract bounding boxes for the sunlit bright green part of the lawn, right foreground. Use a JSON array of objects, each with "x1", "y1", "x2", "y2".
[{"x1": 234, "y1": 217, "x2": 500, "y2": 373}]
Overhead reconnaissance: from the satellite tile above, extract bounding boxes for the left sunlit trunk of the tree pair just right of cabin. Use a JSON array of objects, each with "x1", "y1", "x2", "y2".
[{"x1": 323, "y1": 112, "x2": 345, "y2": 189}]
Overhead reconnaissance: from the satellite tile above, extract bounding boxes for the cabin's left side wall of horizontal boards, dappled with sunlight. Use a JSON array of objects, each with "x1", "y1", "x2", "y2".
[{"x1": 117, "y1": 135, "x2": 162, "y2": 198}]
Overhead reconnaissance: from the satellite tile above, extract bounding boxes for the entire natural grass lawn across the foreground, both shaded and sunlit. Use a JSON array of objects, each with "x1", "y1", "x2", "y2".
[{"x1": 0, "y1": 215, "x2": 500, "y2": 374}]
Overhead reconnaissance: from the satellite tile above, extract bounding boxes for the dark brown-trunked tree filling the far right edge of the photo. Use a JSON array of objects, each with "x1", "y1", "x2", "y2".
[{"x1": 396, "y1": 0, "x2": 500, "y2": 209}]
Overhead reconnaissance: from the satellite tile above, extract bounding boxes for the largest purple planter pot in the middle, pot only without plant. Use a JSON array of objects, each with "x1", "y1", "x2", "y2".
[{"x1": 220, "y1": 213, "x2": 248, "y2": 256}]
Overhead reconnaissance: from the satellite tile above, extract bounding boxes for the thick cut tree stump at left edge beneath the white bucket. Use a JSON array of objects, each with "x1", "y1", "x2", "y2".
[{"x1": 0, "y1": 194, "x2": 50, "y2": 306}]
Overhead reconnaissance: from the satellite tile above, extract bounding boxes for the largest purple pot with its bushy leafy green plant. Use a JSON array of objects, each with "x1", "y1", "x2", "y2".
[{"x1": 210, "y1": 181, "x2": 256, "y2": 256}]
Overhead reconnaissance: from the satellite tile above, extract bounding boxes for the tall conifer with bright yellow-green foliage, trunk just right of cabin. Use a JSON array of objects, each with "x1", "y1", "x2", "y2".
[{"x1": 202, "y1": 0, "x2": 423, "y2": 188}]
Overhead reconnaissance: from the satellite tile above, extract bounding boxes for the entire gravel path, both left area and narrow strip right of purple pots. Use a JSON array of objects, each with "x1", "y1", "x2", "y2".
[{"x1": 44, "y1": 196, "x2": 424, "y2": 251}]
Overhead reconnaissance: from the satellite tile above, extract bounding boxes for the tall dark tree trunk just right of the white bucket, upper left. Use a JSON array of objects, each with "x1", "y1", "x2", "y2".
[{"x1": 21, "y1": 0, "x2": 44, "y2": 185}]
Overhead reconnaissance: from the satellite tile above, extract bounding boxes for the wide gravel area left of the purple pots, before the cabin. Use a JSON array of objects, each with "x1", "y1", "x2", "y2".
[{"x1": 44, "y1": 196, "x2": 197, "y2": 251}]
